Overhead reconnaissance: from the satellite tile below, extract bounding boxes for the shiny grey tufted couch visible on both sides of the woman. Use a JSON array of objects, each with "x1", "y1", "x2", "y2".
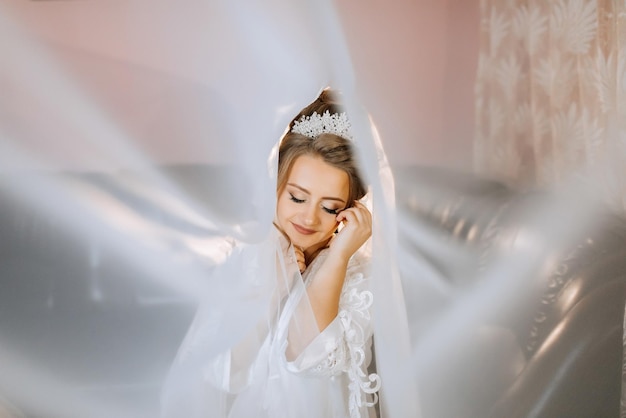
[{"x1": 0, "y1": 167, "x2": 626, "y2": 418}]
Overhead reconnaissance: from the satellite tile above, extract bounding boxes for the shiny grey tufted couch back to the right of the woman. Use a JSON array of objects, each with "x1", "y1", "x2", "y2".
[{"x1": 398, "y1": 167, "x2": 626, "y2": 418}]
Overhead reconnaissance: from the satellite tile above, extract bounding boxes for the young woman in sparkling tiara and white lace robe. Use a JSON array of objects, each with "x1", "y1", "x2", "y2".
[{"x1": 161, "y1": 90, "x2": 380, "y2": 418}]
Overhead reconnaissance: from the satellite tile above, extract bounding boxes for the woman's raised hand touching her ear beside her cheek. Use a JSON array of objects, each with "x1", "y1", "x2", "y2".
[{"x1": 330, "y1": 202, "x2": 372, "y2": 260}]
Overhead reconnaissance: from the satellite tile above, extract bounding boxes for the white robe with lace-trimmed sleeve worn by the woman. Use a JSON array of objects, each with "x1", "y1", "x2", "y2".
[{"x1": 197, "y1": 230, "x2": 380, "y2": 418}]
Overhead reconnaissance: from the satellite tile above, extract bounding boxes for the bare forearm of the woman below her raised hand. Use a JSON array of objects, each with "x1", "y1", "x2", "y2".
[{"x1": 307, "y1": 254, "x2": 349, "y2": 331}]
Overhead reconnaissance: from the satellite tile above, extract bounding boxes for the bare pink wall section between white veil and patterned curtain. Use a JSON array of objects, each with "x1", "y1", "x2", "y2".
[{"x1": 337, "y1": 0, "x2": 479, "y2": 169}]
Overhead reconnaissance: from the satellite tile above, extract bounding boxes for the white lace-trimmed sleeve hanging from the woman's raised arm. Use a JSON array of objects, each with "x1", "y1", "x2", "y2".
[{"x1": 288, "y1": 254, "x2": 380, "y2": 417}]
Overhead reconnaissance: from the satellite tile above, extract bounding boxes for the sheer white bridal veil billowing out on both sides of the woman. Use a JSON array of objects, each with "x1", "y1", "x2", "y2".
[{"x1": 0, "y1": 0, "x2": 624, "y2": 418}]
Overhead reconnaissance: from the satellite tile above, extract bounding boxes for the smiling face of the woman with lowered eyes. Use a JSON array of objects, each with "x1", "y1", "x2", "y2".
[{"x1": 276, "y1": 155, "x2": 350, "y2": 254}]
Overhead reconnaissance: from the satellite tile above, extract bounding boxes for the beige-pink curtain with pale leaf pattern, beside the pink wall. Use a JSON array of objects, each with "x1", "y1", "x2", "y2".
[{"x1": 474, "y1": 0, "x2": 626, "y2": 210}]
